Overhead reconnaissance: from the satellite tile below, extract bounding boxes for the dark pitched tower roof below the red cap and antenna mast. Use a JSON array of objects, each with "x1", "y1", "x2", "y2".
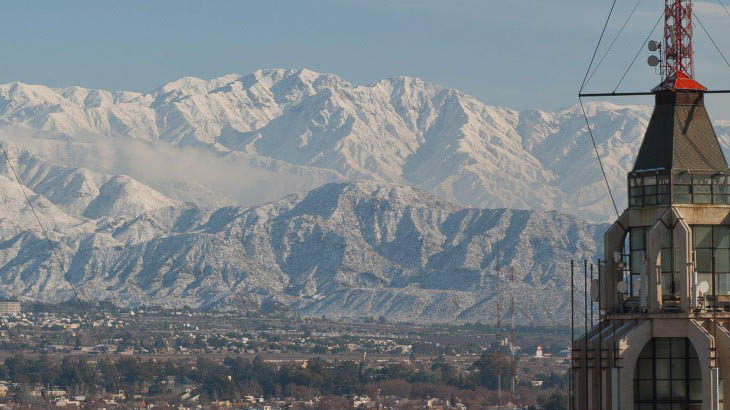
[{"x1": 633, "y1": 91, "x2": 728, "y2": 172}]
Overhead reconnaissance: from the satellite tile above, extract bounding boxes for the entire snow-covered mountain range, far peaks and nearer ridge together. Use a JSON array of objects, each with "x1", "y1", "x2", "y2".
[{"x1": 0, "y1": 70, "x2": 712, "y2": 322}]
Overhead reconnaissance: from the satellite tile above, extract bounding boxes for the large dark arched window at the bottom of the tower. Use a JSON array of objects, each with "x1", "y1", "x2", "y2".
[{"x1": 634, "y1": 337, "x2": 702, "y2": 410}]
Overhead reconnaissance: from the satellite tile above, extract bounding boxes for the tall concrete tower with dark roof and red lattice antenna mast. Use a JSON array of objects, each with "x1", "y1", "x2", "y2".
[{"x1": 571, "y1": 0, "x2": 730, "y2": 410}]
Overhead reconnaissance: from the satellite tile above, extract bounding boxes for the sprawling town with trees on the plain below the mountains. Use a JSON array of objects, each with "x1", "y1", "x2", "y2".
[{"x1": 0, "y1": 301, "x2": 569, "y2": 410}]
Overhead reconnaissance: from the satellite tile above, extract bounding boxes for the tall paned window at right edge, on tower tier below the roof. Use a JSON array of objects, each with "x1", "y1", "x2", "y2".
[{"x1": 692, "y1": 225, "x2": 730, "y2": 301}]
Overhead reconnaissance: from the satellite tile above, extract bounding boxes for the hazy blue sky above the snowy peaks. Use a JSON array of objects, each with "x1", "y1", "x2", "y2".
[{"x1": 0, "y1": 0, "x2": 730, "y2": 115}]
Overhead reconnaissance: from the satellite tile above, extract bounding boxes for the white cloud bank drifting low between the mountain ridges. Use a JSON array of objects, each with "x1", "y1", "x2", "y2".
[{"x1": 0, "y1": 127, "x2": 340, "y2": 210}]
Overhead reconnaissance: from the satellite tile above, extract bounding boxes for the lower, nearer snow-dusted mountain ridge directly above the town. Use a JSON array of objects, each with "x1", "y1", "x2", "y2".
[{"x1": 0, "y1": 149, "x2": 602, "y2": 323}]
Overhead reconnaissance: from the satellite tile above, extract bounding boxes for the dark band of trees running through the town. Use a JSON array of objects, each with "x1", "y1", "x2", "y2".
[{"x1": 0, "y1": 353, "x2": 566, "y2": 406}]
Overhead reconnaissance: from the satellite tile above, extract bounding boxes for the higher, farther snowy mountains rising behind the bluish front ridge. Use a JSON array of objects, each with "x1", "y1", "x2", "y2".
[{"x1": 0, "y1": 69, "x2": 712, "y2": 221}]
